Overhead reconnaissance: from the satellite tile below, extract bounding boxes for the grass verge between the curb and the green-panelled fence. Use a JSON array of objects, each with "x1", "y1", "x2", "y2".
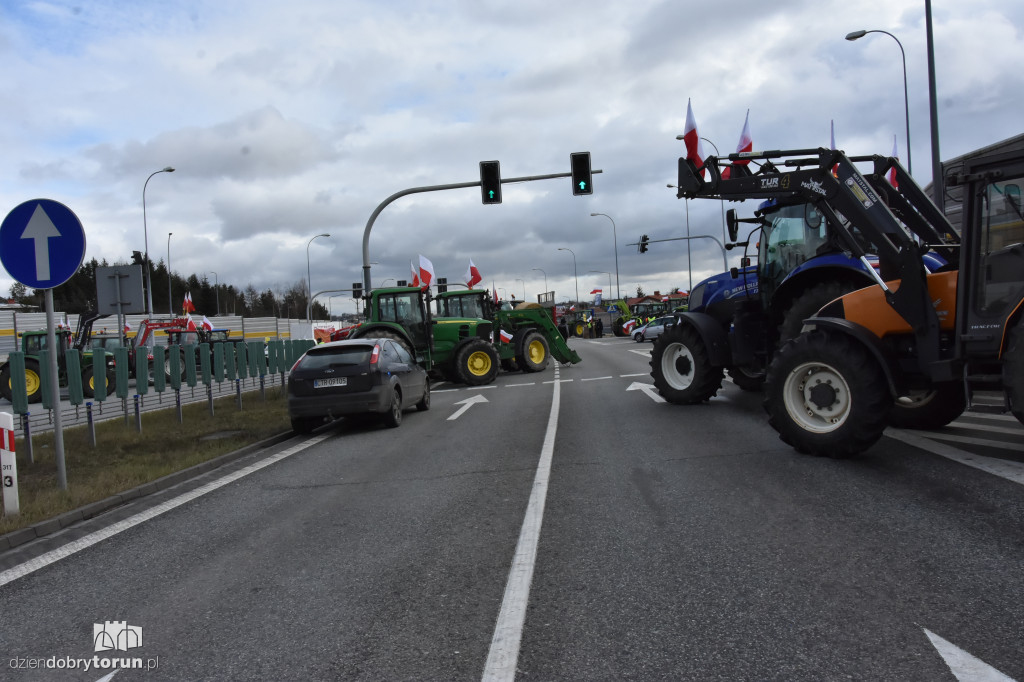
[{"x1": 0, "y1": 388, "x2": 291, "y2": 535}]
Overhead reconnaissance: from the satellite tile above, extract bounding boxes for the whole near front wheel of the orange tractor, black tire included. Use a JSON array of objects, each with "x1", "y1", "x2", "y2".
[{"x1": 764, "y1": 331, "x2": 893, "y2": 458}]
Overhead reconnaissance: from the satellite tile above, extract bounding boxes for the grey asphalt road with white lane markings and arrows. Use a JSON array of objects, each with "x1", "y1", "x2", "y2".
[{"x1": 0, "y1": 338, "x2": 1024, "y2": 680}]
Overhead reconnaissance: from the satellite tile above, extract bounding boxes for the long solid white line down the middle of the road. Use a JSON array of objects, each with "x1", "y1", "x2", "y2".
[{"x1": 482, "y1": 368, "x2": 561, "y2": 682}]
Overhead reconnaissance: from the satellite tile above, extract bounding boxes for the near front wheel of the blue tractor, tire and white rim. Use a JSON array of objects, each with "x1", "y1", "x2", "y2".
[{"x1": 650, "y1": 325, "x2": 724, "y2": 404}]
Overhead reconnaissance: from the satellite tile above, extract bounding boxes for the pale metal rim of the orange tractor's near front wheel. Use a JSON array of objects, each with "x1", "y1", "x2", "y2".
[{"x1": 782, "y1": 363, "x2": 852, "y2": 433}]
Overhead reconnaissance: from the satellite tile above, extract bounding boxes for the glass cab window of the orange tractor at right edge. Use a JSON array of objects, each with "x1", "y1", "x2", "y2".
[{"x1": 974, "y1": 178, "x2": 1024, "y2": 316}]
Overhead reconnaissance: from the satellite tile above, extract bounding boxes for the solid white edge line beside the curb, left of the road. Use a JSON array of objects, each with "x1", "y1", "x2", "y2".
[{"x1": 0, "y1": 433, "x2": 332, "y2": 587}]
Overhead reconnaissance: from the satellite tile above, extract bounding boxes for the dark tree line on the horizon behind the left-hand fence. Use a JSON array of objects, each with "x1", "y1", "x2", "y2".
[{"x1": 10, "y1": 258, "x2": 329, "y2": 319}]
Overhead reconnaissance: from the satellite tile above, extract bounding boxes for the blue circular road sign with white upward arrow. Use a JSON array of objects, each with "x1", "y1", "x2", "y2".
[{"x1": 0, "y1": 199, "x2": 85, "y2": 289}]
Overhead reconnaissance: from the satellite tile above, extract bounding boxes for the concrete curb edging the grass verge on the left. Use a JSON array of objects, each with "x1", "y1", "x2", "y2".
[{"x1": 0, "y1": 431, "x2": 294, "y2": 552}]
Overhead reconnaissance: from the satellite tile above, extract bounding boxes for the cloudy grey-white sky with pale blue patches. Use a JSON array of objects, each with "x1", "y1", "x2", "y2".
[{"x1": 0, "y1": 0, "x2": 1024, "y2": 311}]
